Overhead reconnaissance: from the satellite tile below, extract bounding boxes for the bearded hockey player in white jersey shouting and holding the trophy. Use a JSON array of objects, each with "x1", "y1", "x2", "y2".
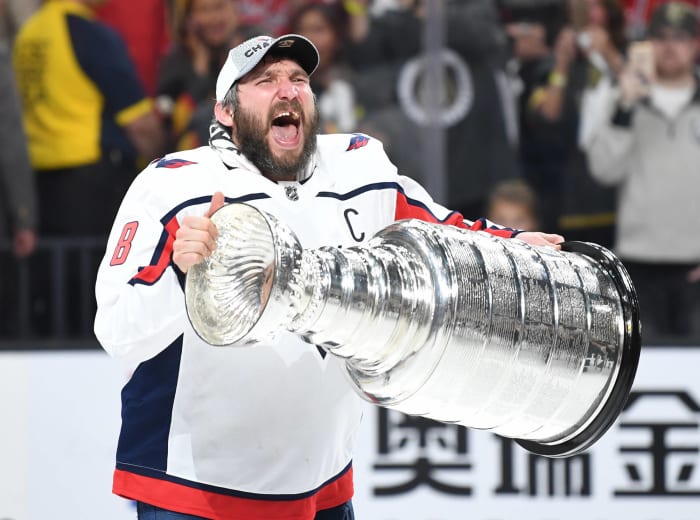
[{"x1": 95, "y1": 35, "x2": 563, "y2": 520}]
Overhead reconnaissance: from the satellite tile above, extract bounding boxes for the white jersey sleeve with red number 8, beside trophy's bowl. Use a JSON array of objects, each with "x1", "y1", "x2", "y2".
[{"x1": 94, "y1": 166, "x2": 206, "y2": 365}]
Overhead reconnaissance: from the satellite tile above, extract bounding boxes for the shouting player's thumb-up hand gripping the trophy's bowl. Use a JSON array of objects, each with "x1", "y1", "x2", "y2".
[{"x1": 173, "y1": 191, "x2": 224, "y2": 273}]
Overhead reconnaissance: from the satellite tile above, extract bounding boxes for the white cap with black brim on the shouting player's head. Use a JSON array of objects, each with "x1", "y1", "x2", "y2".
[{"x1": 216, "y1": 34, "x2": 319, "y2": 101}]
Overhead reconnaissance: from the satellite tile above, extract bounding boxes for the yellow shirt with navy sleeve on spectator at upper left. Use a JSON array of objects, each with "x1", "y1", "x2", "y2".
[{"x1": 13, "y1": 0, "x2": 152, "y2": 170}]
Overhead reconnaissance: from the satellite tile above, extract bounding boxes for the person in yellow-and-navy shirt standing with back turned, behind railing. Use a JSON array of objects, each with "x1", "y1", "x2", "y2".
[{"x1": 13, "y1": 0, "x2": 162, "y2": 333}]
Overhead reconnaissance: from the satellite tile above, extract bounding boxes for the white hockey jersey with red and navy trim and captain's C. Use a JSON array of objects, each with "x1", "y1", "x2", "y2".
[{"x1": 95, "y1": 134, "x2": 513, "y2": 520}]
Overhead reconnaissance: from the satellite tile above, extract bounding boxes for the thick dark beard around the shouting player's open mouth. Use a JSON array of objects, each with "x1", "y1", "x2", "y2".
[{"x1": 233, "y1": 100, "x2": 319, "y2": 181}]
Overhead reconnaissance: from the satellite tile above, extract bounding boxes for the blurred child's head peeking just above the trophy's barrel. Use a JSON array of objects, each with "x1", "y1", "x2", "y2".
[{"x1": 485, "y1": 179, "x2": 540, "y2": 231}]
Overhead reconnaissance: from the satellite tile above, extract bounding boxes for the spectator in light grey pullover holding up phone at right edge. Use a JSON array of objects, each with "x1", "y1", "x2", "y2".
[{"x1": 588, "y1": 2, "x2": 700, "y2": 343}]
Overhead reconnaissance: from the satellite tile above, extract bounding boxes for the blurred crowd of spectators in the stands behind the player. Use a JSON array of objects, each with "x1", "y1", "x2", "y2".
[{"x1": 0, "y1": 0, "x2": 700, "y2": 343}]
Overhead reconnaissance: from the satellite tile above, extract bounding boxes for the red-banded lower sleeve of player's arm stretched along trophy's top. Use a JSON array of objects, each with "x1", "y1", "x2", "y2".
[{"x1": 395, "y1": 176, "x2": 519, "y2": 238}]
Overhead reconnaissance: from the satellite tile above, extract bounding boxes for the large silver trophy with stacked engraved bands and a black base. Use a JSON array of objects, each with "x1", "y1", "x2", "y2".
[{"x1": 185, "y1": 204, "x2": 641, "y2": 457}]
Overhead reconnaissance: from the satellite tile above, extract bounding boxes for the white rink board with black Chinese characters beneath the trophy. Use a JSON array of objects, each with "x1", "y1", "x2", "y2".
[{"x1": 355, "y1": 348, "x2": 700, "y2": 520}]
